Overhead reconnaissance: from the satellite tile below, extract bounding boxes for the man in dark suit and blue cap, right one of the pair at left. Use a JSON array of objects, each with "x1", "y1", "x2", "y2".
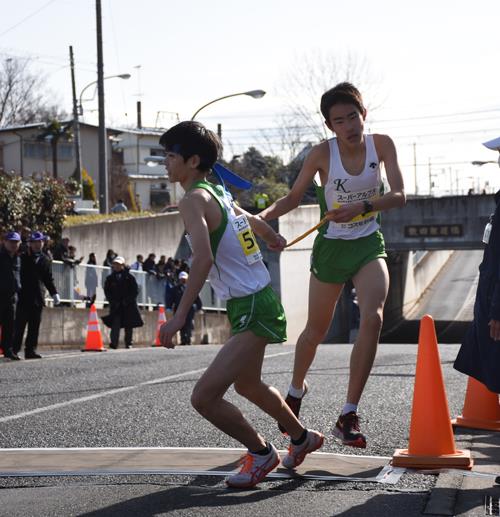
[{"x1": 12, "y1": 232, "x2": 61, "y2": 359}]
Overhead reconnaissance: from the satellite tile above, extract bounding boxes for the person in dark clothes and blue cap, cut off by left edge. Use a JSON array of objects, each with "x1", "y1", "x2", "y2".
[{"x1": 0, "y1": 232, "x2": 21, "y2": 361}]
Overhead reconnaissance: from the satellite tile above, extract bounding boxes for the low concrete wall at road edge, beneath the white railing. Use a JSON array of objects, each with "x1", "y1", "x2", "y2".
[{"x1": 39, "y1": 307, "x2": 230, "y2": 350}]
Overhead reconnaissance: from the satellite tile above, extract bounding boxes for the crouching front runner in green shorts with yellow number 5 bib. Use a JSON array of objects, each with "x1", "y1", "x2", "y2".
[{"x1": 160, "y1": 121, "x2": 324, "y2": 488}]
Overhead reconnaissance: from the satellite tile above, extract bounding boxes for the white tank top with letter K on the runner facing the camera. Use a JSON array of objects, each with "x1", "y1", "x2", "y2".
[{"x1": 324, "y1": 135, "x2": 383, "y2": 240}]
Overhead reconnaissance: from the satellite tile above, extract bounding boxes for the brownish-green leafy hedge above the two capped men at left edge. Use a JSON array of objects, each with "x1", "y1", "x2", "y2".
[{"x1": 0, "y1": 174, "x2": 68, "y2": 239}]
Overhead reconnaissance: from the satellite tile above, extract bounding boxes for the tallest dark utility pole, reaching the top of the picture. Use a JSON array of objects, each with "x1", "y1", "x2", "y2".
[{"x1": 95, "y1": 0, "x2": 108, "y2": 214}]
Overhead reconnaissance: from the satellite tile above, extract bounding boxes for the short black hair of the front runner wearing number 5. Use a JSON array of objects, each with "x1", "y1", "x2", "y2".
[{"x1": 160, "y1": 120, "x2": 222, "y2": 172}]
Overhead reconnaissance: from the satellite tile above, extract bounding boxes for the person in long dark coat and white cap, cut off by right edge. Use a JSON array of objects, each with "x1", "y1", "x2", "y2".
[{"x1": 453, "y1": 137, "x2": 500, "y2": 393}]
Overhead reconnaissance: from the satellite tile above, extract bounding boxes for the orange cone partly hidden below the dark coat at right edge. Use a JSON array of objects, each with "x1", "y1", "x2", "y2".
[{"x1": 451, "y1": 377, "x2": 500, "y2": 431}]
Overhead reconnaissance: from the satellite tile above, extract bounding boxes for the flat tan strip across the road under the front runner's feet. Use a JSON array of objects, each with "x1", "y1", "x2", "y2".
[{"x1": 0, "y1": 447, "x2": 405, "y2": 484}]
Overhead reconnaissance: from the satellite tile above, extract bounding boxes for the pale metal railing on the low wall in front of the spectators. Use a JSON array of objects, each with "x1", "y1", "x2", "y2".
[{"x1": 46, "y1": 260, "x2": 226, "y2": 311}]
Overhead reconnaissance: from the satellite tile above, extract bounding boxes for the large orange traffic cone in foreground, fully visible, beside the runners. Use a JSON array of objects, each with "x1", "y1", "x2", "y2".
[{"x1": 392, "y1": 315, "x2": 473, "y2": 469}]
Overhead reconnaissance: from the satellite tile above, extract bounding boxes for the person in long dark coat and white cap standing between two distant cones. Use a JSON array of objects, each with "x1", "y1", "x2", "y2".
[{"x1": 102, "y1": 257, "x2": 143, "y2": 349}]
